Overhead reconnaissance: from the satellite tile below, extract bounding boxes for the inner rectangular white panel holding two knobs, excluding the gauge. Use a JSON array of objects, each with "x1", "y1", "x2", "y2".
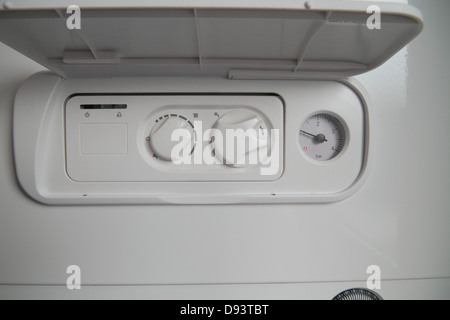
[{"x1": 65, "y1": 94, "x2": 284, "y2": 182}]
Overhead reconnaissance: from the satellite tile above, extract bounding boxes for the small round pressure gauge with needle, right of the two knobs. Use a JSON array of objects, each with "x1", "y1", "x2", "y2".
[{"x1": 299, "y1": 113, "x2": 346, "y2": 161}]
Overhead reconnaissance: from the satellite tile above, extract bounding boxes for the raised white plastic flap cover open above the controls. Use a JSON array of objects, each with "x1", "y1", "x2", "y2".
[{"x1": 0, "y1": 0, "x2": 423, "y2": 79}]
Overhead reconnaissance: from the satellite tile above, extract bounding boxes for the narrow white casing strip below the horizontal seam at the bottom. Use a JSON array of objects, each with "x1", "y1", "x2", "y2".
[{"x1": 0, "y1": 279, "x2": 450, "y2": 300}]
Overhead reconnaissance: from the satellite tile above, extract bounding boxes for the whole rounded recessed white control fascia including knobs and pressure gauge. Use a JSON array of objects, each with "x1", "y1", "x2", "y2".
[{"x1": 14, "y1": 74, "x2": 370, "y2": 205}]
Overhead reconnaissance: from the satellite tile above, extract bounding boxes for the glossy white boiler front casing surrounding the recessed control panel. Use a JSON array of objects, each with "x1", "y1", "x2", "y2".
[{"x1": 0, "y1": 0, "x2": 450, "y2": 299}]
